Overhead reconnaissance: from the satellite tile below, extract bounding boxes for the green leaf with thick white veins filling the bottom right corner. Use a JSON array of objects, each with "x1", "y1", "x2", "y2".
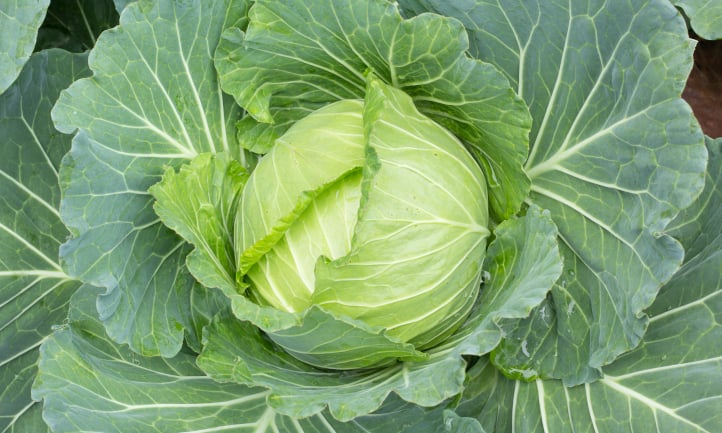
[{"x1": 459, "y1": 140, "x2": 722, "y2": 433}]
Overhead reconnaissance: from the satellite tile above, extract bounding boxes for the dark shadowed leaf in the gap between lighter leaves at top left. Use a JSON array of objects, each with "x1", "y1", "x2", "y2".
[{"x1": 35, "y1": 0, "x2": 118, "y2": 52}]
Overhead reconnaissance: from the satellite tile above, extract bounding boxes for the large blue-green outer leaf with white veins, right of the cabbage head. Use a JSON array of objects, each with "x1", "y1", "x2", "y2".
[{"x1": 401, "y1": 0, "x2": 706, "y2": 384}]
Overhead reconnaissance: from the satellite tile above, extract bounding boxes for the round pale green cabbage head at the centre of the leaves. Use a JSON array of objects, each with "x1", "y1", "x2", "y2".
[{"x1": 234, "y1": 78, "x2": 489, "y2": 368}]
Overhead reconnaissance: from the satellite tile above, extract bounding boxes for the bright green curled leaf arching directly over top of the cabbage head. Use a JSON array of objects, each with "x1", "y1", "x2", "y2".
[{"x1": 216, "y1": 0, "x2": 529, "y2": 218}]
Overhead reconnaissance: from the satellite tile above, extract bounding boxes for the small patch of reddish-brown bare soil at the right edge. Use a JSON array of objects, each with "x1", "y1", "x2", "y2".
[{"x1": 682, "y1": 40, "x2": 722, "y2": 138}]
